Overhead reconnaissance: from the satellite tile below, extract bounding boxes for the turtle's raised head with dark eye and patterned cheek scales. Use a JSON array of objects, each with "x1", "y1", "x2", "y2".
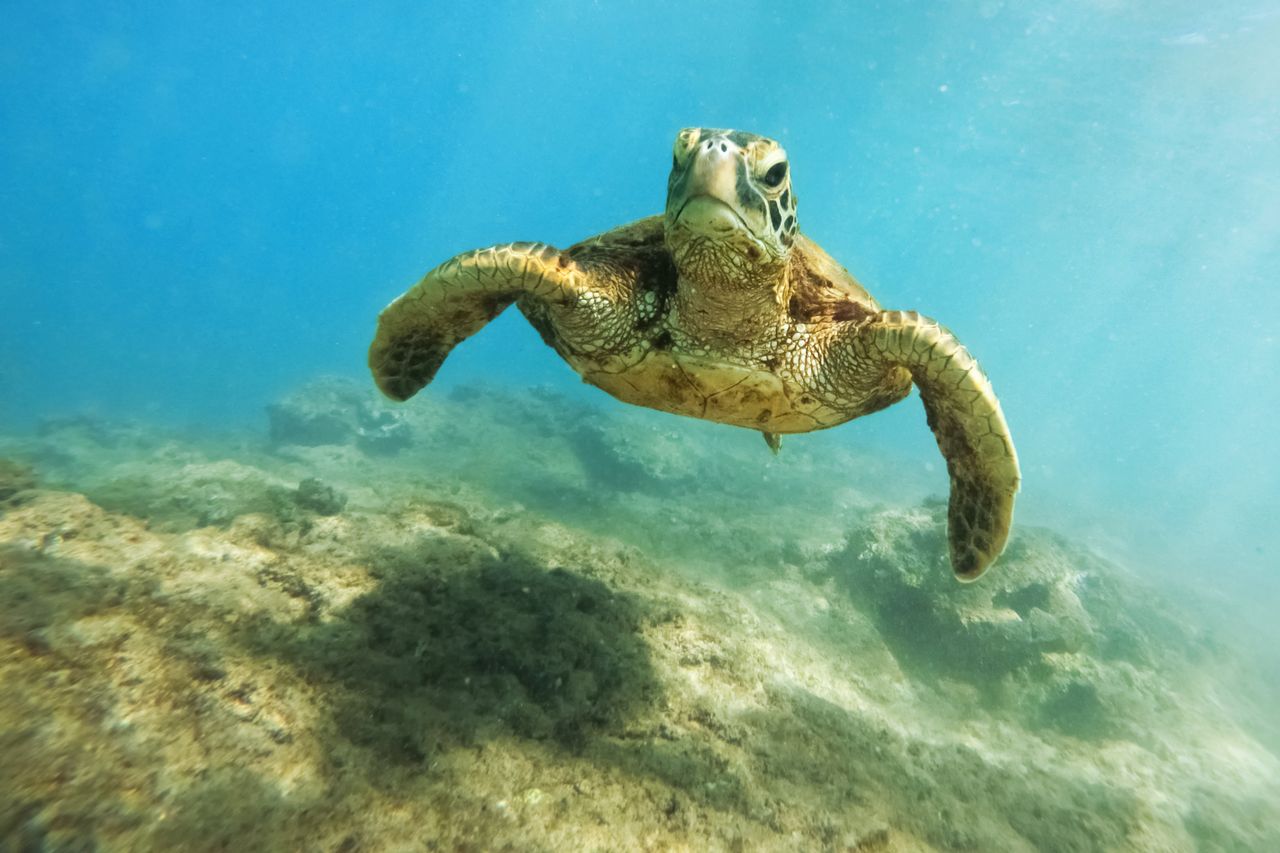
[{"x1": 666, "y1": 127, "x2": 796, "y2": 272}]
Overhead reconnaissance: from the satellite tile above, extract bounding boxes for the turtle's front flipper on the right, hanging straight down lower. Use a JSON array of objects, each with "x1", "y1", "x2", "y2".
[{"x1": 856, "y1": 311, "x2": 1021, "y2": 580}]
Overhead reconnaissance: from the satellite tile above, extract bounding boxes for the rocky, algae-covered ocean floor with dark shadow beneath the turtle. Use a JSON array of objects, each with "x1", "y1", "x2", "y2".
[{"x1": 0, "y1": 380, "x2": 1280, "y2": 852}]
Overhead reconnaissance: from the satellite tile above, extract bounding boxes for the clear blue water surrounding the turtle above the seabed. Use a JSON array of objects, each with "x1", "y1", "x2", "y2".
[{"x1": 0, "y1": 0, "x2": 1280, "y2": 611}]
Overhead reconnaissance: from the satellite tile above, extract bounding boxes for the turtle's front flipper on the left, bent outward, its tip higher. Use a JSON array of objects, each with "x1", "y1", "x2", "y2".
[{"x1": 369, "y1": 243, "x2": 586, "y2": 400}]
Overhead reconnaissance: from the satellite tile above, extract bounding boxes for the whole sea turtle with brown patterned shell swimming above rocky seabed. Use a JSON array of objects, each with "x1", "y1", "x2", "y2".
[{"x1": 369, "y1": 128, "x2": 1020, "y2": 580}]
